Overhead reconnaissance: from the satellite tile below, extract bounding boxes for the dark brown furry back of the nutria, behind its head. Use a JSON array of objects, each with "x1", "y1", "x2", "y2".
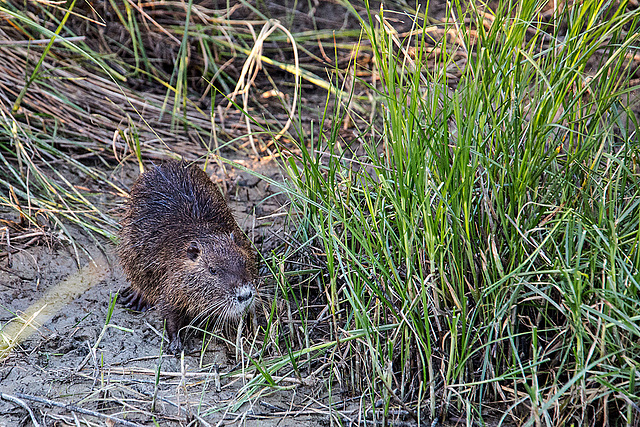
[{"x1": 118, "y1": 161, "x2": 241, "y2": 304}]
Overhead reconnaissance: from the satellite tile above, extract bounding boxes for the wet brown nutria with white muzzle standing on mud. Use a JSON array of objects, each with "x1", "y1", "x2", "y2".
[{"x1": 118, "y1": 161, "x2": 257, "y2": 353}]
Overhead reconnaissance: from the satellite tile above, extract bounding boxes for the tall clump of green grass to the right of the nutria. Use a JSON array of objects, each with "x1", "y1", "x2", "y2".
[{"x1": 278, "y1": 0, "x2": 640, "y2": 426}]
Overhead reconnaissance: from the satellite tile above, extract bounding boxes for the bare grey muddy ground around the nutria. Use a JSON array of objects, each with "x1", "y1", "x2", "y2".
[{"x1": 0, "y1": 157, "x2": 338, "y2": 426}]
